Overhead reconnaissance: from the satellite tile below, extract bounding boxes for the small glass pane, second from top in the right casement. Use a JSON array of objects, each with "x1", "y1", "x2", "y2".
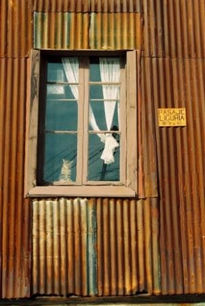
[{"x1": 90, "y1": 85, "x2": 120, "y2": 100}]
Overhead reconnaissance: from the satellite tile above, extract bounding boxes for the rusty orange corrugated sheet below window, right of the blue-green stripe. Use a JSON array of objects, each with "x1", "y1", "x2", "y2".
[{"x1": 96, "y1": 199, "x2": 160, "y2": 296}]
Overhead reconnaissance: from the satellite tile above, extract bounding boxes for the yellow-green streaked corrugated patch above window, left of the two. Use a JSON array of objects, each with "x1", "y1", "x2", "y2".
[{"x1": 34, "y1": 13, "x2": 89, "y2": 49}]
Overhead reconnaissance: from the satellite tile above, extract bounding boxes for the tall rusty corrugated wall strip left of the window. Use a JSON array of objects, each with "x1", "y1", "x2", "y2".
[{"x1": 0, "y1": 0, "x2": 32, "y2": 298}]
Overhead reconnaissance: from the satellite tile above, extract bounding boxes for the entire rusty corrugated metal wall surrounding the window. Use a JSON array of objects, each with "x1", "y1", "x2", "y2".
[{"x1": 0, "y1": 0, "x2": 205, "y2": 298}]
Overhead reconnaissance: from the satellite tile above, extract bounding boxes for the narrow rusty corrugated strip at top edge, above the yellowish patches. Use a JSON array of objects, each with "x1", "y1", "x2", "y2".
[{"x1": 32, "y1": 0, "x2": 141, "y2": 13}]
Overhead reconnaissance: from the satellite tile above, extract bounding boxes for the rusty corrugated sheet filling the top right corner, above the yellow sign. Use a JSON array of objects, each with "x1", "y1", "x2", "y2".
[{"x1": 142, "y1": 0, "x2": 205, "y2": 58}]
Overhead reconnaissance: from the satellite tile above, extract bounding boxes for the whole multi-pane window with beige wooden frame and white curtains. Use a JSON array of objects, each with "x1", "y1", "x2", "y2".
[{"x1": 26, "y1": 50, "x2": 137, "y2": 197}]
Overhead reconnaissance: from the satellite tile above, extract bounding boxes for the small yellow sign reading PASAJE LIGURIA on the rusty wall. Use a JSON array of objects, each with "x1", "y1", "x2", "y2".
[{"x1": 158, "y1": 108, "x2": 186, "y2": 126}]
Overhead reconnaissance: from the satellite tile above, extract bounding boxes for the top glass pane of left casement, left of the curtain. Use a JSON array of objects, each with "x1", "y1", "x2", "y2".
[{"x1": 47, "y1": 62, "x2": 67, "y2": 82}]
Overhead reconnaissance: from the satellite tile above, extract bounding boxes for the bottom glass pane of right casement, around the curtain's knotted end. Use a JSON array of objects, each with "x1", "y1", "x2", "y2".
[{"x1": 88, "y1": 134, "x2": 120, "y2": 181}]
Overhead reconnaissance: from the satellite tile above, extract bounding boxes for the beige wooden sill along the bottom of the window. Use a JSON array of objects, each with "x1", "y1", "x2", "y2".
[{"x1": 26, "y1": 186, "x2": 136, "y2": 198}]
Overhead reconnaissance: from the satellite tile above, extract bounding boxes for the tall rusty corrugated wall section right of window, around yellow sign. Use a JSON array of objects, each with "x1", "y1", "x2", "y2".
[{"x1": 142, "y1": 0, "x2": 205, "y2": 294}]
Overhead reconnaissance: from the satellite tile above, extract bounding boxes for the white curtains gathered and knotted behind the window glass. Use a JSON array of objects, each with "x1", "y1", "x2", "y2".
[{"x1": 62, "y1": 57, "x2": 120, "y2": 164}]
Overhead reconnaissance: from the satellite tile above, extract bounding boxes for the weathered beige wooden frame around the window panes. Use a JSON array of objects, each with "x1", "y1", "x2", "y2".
[{"x1": 25, "y1": 50, "x2": 138, "y2": 197}]
